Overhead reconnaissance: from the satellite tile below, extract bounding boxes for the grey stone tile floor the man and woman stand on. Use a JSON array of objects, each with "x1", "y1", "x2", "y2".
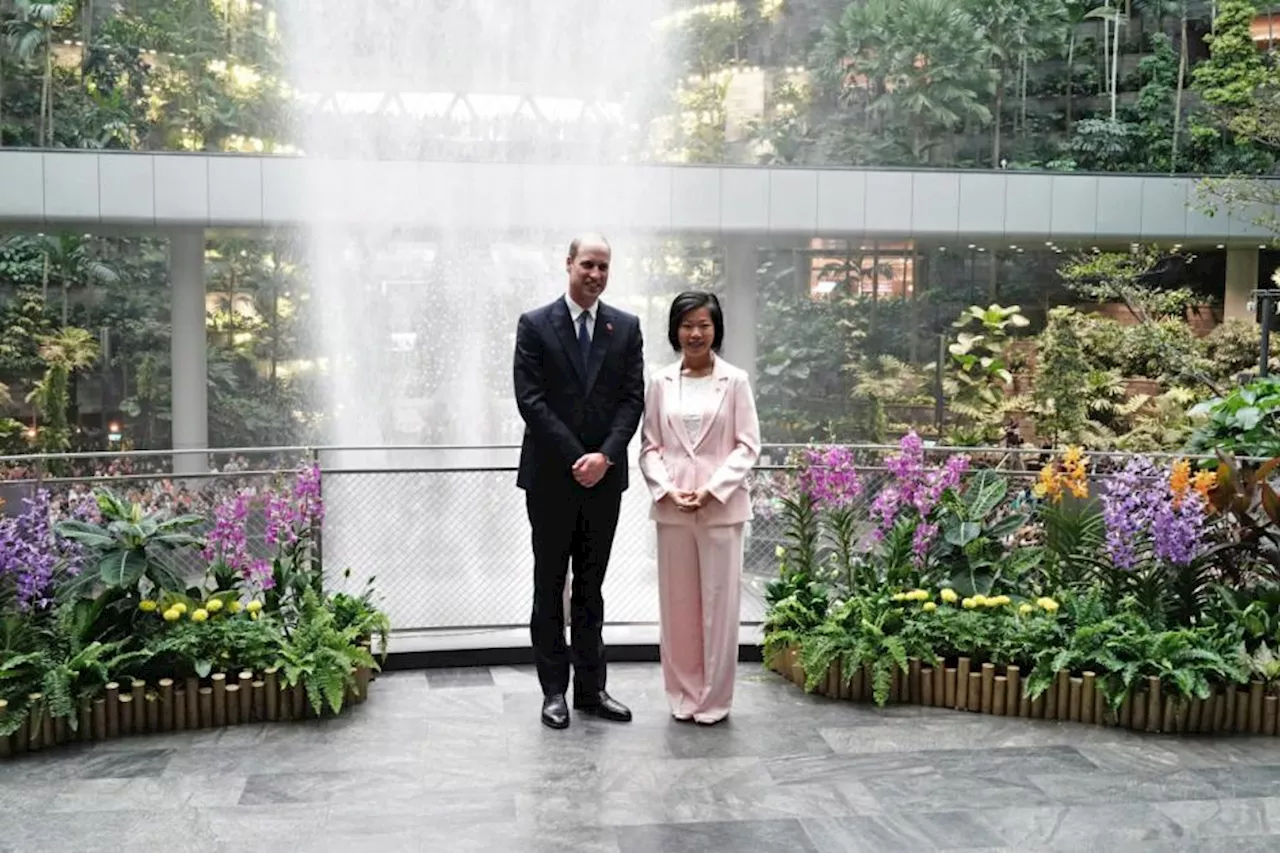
[{"x1": 0, "y1": 663, "x2": 1280, "y2": 853}]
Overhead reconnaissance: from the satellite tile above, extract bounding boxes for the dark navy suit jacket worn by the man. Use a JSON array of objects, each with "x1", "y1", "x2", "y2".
[{"x1": 515, "y1": 297, "x2": 644, "y2": 493}]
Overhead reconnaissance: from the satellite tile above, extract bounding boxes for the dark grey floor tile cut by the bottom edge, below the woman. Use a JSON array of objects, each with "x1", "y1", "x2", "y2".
[{"x1": 617, "y1": 820, "x2": 818, "y2": 853}]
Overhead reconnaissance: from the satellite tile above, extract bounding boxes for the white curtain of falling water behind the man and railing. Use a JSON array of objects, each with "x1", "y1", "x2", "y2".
[{"x1": 280, "y1": 0, "x2": 686, "y2": 628}]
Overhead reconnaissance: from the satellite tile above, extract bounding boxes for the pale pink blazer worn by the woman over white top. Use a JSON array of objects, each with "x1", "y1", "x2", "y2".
[{"x1": 640, "y1": 357, "x2": 760, "y2": 525}]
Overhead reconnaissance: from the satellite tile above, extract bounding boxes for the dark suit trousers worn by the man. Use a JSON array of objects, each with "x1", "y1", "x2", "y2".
[{"x1": 525, "y1": 489, "x2": 622, "y2": 702}]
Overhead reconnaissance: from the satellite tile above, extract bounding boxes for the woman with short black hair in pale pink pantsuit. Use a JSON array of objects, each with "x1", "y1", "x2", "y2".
[{"x1": 640, "y1": 292, "x2": 760, "y2": 724}]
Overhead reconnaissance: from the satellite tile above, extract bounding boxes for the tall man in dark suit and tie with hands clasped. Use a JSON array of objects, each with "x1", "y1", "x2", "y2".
[{"x1": 515, "y1": 234, "x2": 644, "y2": 729}]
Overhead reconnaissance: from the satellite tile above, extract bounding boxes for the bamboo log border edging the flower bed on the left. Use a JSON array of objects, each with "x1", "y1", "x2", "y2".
[{"x1": 0, "y1": 667, "x2": 373, "y2": 761}]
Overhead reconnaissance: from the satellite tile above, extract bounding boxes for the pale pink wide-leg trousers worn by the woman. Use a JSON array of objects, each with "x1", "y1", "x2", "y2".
[{"x1": 658, "y1": 514, "x2": 744, "y2": 722}]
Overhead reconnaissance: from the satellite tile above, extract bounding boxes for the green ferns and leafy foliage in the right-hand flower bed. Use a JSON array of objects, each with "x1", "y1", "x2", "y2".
[{"x1": 765, "y1": 440, "x2": 1280, "y2": 711}]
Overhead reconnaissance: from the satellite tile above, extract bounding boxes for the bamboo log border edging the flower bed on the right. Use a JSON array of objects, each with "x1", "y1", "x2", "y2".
[{"x1": 768, "y1": 647, "x2": 1280, "y2": 737}]
